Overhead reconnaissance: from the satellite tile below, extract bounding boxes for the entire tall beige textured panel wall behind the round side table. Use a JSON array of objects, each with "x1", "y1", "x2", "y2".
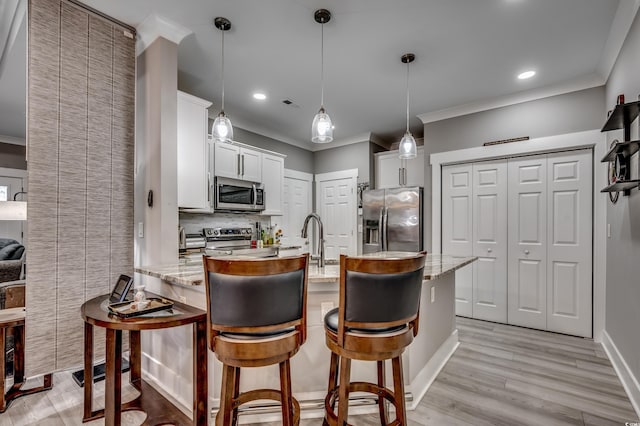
[{"x1": 26, "y1": 0, "x2": 135, "y2": 376}]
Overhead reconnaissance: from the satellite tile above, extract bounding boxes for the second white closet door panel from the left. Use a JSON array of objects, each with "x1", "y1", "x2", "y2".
[{"x1": 472, "y1": 160, "x2": 507, "y2": 322}]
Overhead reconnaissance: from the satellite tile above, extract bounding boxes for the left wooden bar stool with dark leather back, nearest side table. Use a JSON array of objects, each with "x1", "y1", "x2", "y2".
[{"x1": 203, "y1": 255, "x2": 308, "y2": 426}]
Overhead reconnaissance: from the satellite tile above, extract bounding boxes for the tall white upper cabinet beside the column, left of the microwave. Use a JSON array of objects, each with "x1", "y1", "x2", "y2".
[{"x1": 177, "y1": 91, "x2": 213, "y2": 210}]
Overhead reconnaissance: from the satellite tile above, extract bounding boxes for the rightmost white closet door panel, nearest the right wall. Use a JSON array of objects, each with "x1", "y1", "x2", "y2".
[{"x1": 547, "y1": 150, "x2": 592, "y2": 337}]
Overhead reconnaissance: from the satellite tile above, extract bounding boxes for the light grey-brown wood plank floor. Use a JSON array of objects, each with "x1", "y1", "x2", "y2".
[{"x1": 0, "y1": 318, "x2": 638, "y2": 426}]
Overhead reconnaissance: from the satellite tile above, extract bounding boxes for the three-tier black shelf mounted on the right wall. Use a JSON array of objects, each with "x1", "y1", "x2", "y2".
[{"x1": 600, "y1": 101, "x2": 640, "y2": 197}]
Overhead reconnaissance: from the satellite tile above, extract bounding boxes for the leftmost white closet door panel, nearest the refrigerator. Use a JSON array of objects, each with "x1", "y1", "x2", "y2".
[{"x1": 442, "y1": 164, "x2": 473, "y2": 317}]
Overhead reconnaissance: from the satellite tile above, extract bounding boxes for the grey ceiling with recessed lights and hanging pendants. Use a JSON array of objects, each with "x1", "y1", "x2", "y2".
[{"x1": 0, "y1": 0, "x2": 635, "y2": 150}]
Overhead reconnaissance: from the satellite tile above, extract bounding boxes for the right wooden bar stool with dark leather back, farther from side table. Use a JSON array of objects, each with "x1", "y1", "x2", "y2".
[{"x1": 323, "y1": 253, "x2": 425, "y2": 425}]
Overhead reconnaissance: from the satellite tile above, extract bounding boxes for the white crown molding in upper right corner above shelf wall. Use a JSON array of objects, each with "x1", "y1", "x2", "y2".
[{"x1": 597, "y1": 0, "x2": 640, "y2": 81}]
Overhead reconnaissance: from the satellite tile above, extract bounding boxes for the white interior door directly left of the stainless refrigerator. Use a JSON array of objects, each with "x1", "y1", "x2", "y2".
[{"x1": 316, "y1": 169, "x2": 358, "y2": 259}]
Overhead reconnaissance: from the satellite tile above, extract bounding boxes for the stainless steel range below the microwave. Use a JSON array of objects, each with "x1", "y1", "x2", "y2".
[{"x1": 202, "y1": 227, "x2": 278, "y2": 257}]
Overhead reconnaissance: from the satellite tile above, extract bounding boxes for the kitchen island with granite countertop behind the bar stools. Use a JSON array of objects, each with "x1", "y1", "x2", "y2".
[{"x1": 136, "y1": 252, "x2": 475, "y2": 422}]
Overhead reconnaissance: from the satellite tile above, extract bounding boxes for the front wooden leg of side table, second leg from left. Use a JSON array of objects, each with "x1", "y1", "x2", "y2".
[{"x1": 104, "y1": 328, "x2": 122, "y2": 426}]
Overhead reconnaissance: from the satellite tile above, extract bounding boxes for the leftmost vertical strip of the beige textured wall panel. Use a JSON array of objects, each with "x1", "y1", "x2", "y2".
[{"x1": 26, "y1": 0, "x2": 61, "y2": 375}]
